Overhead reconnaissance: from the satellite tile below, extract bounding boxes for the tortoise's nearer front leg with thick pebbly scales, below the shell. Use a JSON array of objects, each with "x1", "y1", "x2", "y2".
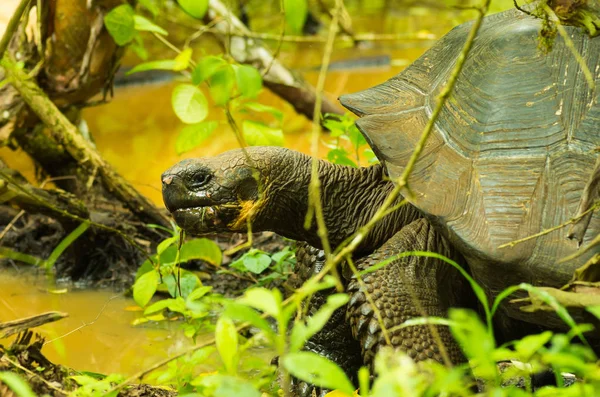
[{"x1": 346, "y1": 219, "x2": 473, "y2": 365}]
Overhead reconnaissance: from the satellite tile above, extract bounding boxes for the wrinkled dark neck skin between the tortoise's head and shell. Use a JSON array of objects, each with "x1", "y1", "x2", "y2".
[{"x1": 254, "y1": 149, "x2": 421, "y2": 253}]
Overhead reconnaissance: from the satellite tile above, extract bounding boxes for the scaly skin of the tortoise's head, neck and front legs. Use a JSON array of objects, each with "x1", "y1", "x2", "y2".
[{"x1": 163, "y1": 147, "x2": 474, "y2": 395}]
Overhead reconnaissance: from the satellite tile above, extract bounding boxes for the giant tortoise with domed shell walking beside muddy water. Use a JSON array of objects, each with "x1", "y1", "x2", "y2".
[{"x1": 163, "y1": 6, "x2": 600, "y2": 378}]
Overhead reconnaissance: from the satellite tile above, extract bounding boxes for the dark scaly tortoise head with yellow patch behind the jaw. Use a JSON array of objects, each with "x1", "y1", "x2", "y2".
[{"x1": 162, "y1": 150, "x2": 268, "y2": 234}]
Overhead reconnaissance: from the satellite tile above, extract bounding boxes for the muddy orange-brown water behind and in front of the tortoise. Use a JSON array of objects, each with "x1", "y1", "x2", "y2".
[{"x1": 0, "y1": 2, "x2": 512, "y2": 375}]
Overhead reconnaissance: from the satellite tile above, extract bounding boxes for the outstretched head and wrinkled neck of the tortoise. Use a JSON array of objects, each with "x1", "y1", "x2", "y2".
[{"x1": 162, "y1": 146, "x2": 421, "y2": 253}]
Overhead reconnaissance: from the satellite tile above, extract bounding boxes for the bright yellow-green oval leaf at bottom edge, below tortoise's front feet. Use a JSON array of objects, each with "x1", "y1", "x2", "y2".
[{"x1": 283, "y1": 352, "x2": 354, "y2": 396}]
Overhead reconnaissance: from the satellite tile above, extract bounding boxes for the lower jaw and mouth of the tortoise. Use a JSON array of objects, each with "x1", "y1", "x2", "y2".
[{"x1": 171, "y1": 205, "x2": 239, "y2": 234}]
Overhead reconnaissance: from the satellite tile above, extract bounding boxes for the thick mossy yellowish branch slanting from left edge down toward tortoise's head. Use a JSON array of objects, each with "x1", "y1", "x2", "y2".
[{"x1": 0, "y1": 57, "x2": 170, "y2": 227}]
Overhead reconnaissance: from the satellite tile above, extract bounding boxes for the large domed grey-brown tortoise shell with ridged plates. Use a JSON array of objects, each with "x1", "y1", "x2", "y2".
[{"x1": 340, "y1": 10, "x2": 600, "y2": 318}]
